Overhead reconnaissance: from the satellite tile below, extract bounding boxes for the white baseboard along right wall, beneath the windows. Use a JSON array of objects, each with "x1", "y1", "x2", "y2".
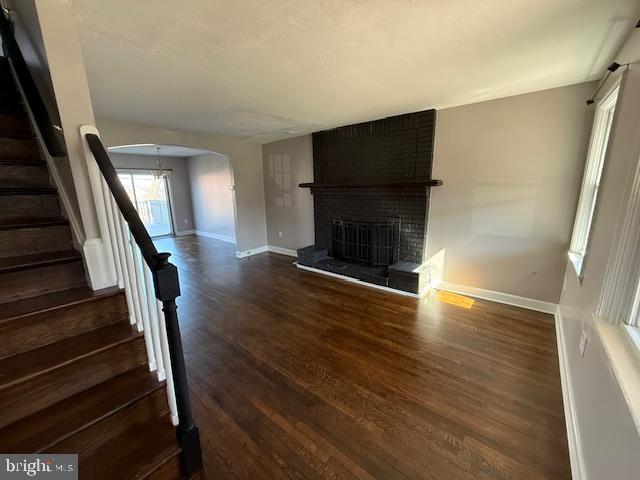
[{"x1": 554, "y1": 308, "x2": 587, "y2": 480}]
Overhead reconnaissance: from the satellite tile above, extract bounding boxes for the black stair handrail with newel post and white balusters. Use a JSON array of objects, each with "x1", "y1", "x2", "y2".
[{"x1": 83, "y1": 133, "x2": 202, "y2": 474}]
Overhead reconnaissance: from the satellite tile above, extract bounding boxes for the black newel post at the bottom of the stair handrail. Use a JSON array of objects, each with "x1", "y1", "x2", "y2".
[{"x1": 153, "y1": 253, "x2": 202, "y2": 475}]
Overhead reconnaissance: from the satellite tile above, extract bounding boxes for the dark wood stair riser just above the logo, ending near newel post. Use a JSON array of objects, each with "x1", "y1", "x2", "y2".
[{"x1": 52, "y1": 388, "x2": 169, "y2": 456}]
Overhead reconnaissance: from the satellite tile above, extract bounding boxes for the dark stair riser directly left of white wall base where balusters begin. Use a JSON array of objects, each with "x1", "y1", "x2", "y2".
[{"x1": 0, "y1": 260, "x2": 86, "y2": 303}]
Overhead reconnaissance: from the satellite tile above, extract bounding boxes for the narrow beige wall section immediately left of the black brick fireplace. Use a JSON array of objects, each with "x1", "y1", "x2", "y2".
[{"x1": 262, "y1": 135, "x2": 315, "y2": 250}]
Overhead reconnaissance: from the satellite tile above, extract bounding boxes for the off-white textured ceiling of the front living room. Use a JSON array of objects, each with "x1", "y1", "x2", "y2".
[{"x1": 74, "y1": 0, "x2": 640, "y2": 143}]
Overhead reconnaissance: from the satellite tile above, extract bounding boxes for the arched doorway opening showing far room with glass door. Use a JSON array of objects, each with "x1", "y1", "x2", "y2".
[{"x1": 109, "y1": 144, "x2": 236, "y2": 244}]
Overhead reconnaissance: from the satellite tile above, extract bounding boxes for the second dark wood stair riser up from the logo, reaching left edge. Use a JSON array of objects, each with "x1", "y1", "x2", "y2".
[{"x1": 0, "y1": 336, "x2": 147, "y2": 428}]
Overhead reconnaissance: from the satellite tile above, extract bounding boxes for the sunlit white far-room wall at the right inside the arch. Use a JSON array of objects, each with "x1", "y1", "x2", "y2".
[{"x1": 187, "y1": 153, "x2": 236, "y2": 241}]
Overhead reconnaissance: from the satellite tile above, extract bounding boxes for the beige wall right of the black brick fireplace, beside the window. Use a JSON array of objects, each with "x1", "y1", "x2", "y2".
[{"x1": 426, "y1": 83, "x2": 594, "y2": 303}]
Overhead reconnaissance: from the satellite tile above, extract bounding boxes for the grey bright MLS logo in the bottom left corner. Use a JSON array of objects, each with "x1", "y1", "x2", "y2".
[{"x1": 0, "y1": 454, "x2": 78, "y2": 480}]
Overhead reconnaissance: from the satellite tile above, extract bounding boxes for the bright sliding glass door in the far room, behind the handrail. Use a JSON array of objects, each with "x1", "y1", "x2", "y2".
[{"x1": 118, "y1": 171, "x2": 174, "y2": 237}]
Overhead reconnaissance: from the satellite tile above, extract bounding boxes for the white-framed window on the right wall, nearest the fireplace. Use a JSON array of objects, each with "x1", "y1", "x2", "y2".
[{"x1": 569, "y1": 85, "x2": 619, "y2": 279}]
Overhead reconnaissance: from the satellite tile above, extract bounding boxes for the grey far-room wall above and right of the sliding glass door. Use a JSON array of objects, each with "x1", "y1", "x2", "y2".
[{"x1": 109, "y1": 152, "x2": 193, "y2": 233}]
